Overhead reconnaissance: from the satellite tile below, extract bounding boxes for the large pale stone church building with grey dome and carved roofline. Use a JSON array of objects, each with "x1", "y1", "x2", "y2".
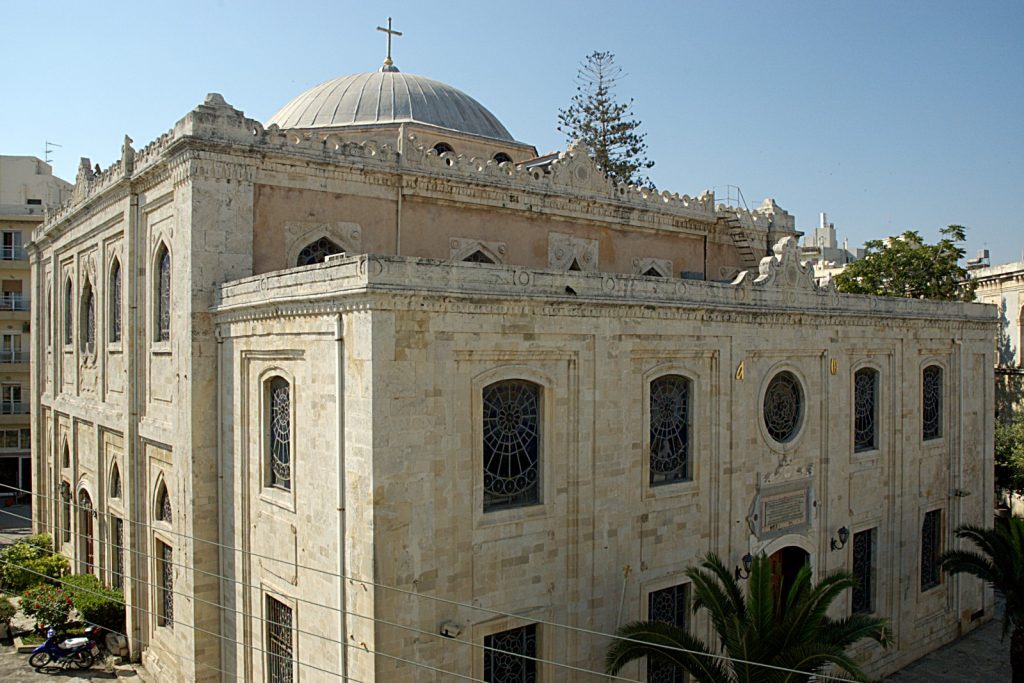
[{"x1": 29, "y1": 38, "x2": 996, "y2": 683}]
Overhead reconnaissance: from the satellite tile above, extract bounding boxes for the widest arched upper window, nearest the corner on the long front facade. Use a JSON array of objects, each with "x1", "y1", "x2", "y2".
[{"x1": 482, "y1": 380, "x2": 541, "y2": 512}]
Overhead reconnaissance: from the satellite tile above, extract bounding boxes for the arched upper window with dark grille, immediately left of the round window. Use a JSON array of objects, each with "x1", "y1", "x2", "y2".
[{"x1": 650, "y1": 375, "x2": 690, "y2": 486}]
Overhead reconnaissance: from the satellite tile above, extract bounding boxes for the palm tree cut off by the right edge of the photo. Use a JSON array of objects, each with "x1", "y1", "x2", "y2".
[{"x1": 939, "y1": 517, "x2": 1024, "y2": 683}]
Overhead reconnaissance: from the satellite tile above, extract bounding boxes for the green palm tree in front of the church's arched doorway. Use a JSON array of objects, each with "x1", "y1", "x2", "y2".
[{"x1": 605, "y1": 553, "x2": 886, "y2": 683}]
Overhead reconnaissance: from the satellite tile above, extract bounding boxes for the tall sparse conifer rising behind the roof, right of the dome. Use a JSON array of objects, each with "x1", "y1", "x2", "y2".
[{"x1": 558, "y1": 51, "x2": 654, "y2": 186}]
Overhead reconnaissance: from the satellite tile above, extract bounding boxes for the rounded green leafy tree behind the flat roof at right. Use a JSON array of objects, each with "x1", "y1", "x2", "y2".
[{"x1": 834, "y1": 225, "x2": 974, "y2": 301}]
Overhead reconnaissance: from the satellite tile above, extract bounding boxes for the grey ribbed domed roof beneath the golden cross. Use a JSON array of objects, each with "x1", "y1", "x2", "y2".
[{"x1": 266, "y1": 71, "x2": 515, "y2": 142}]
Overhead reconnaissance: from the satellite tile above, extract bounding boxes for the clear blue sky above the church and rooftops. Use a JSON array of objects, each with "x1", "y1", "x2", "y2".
[{"x1": 0, "y1": 0, "x2": 1024, "y2": 263}]
